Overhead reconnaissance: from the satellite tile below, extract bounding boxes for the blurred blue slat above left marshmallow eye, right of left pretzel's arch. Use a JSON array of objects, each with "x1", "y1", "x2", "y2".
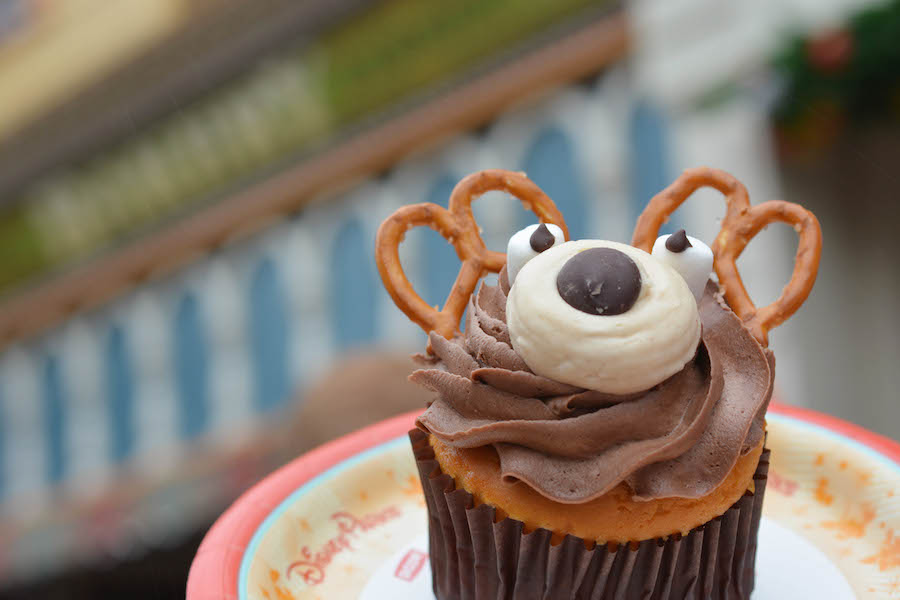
[{"x1": 521, "y1": 127, "x2": 590, "y2": 240}]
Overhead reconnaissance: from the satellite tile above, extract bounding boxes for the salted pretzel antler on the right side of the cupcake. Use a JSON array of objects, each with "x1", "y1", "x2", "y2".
[{"x1": 631, "y1": 167, "x2": 822, "y2": 346}]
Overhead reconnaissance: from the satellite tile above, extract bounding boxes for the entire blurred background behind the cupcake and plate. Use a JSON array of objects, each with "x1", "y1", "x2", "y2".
[{"x1": 0, "y1": 0, "x2": 900, "y2": 598}]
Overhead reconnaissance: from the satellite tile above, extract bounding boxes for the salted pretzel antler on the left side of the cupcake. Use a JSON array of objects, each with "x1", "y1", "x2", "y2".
[{"x1": 375, "y1": 169, "x2": 569, "y2": 339}]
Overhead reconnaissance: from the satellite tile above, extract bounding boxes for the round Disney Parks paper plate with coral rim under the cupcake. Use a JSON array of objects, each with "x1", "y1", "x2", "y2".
[{"x1": 187, "y1": 405, "x2": 900, "y2": 600}]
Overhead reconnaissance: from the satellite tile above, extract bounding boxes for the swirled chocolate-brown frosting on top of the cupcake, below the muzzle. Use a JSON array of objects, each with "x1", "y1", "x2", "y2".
[{"x1": 410, "y1": 269, "x2": 775, "y2": 504}]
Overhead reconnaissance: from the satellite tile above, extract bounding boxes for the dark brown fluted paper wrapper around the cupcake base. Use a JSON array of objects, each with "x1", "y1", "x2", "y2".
[{"x1": 409, "y1": 429, "x2": 769, "y2": 600}]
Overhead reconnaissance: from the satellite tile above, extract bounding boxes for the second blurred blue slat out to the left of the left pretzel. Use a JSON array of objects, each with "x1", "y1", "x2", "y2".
[{"x1": 250, "y1": 259, "x2": 290, "y2": 411}]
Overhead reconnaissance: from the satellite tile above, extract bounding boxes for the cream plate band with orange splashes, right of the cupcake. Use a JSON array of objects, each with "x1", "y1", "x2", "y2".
[{"x1": 763, "y1": 409, "x2": 900, "y2": 599}]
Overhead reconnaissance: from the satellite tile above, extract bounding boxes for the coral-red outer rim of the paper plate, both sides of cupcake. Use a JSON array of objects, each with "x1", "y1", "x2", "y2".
[{"x1": 187, "y1": 403, "x2": 900, "y2": 600}]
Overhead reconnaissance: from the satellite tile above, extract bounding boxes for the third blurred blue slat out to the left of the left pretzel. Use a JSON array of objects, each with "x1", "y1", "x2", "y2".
[{"x1": 173, "y1": 294, "x2": 209, "y2": 439}]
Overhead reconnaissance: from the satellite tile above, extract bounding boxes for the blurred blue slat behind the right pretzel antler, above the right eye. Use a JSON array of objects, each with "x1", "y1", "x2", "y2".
[{"x1": 628, "y1": 101, "x2": 677, "y2": 233}]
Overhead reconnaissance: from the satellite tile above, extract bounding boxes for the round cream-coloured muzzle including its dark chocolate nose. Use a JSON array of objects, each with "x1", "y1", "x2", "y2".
[{"x1": 506, "y1": 236, "x2": 712, "y2": 394}]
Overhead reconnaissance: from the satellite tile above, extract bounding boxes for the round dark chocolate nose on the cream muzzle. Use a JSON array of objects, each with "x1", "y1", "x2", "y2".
[{"x1": 556, "y1": 248, "x2": 641, "y2": 316}]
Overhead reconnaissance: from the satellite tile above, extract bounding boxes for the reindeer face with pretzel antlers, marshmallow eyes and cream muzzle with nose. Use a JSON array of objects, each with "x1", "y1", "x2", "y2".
[{"x1": 375, "y1": 168, "x2": 822, "y2": 395}]
